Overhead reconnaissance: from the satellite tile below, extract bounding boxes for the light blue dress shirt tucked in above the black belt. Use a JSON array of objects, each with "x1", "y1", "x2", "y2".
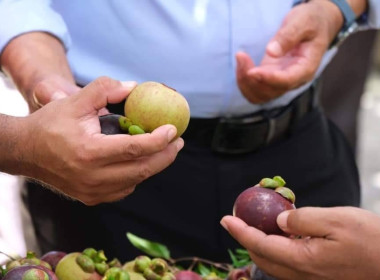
[{"x1": 0, "y1": 0, "x2": 380, "y2": 118}]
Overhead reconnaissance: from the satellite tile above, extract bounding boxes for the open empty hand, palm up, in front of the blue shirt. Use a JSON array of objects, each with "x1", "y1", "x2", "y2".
[{"x1": 236, "y1": 0, "x2": 343, "y2": 103}]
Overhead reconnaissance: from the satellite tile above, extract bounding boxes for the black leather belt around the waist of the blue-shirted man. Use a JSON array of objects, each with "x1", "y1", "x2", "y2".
[{"x1": 182, "y1": 83, "x2": 318, "y2": 155}]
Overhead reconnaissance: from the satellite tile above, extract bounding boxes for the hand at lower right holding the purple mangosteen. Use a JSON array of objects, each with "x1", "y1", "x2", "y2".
[{"x1": 221, "y1": 207, "x2": 380, "y2": 280}]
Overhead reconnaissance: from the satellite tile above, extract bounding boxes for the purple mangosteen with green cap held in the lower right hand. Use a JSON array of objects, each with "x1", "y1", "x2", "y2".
[{"x1": 233, "y1": 176, "x2": 295, "y2": 235}]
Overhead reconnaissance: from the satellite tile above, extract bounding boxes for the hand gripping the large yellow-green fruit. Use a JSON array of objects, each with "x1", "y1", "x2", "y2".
[{"x1": 20, "y1": 77, "x2": 183, "y2": 205}]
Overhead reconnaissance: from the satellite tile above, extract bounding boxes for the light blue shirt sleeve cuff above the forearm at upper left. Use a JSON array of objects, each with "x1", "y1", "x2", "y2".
[{"x1": 0, "y1": 0, "x2": 71, "y2": 53}]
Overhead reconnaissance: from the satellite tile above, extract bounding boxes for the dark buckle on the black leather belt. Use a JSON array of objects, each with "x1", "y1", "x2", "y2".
[{"x1": 211, "y1": 114, "x2": 275, "y2": 155}]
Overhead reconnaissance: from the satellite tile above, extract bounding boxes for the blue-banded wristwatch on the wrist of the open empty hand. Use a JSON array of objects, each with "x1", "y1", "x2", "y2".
[{"x1": 293, "y1": 0, "x2": 359, "y2": 48}]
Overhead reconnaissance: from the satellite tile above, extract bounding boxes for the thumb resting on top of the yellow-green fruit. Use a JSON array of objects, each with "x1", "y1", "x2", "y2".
[{"x1": 74, "y1": 77, "x2": 137, "y2": 112}]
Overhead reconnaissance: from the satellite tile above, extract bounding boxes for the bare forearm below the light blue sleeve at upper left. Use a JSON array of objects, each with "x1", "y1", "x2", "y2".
[{"x1": 0, "y1": 32, "x2": 75, "y2": 107}]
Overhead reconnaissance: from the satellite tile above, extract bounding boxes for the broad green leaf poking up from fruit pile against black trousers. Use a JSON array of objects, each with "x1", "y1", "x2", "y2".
[{"x1": 127, "y1": 232, "x2": 170, "y2": 260}]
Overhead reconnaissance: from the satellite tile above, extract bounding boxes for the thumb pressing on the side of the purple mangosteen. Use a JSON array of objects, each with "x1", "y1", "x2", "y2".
[{"x1": 277, "y1": 207, "x2": 332, "y2": 237}]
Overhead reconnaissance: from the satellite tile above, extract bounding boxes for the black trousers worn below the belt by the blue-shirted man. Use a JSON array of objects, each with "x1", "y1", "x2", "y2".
[{"x1": 27, "y1": 106, "x2": 360, "y2": 261}]
